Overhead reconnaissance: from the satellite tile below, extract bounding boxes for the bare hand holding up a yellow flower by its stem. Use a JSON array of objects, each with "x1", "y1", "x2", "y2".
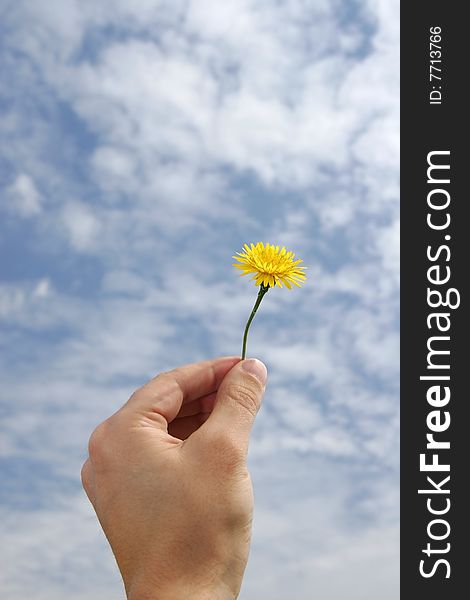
[{"x1": 82, "y1": 357, "x2": 266, "y2": 600}]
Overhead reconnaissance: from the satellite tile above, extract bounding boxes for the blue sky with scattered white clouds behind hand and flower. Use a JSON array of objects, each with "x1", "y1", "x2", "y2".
[{"x1": 0, "y1": 0, "x2": 399, "y2": 600}]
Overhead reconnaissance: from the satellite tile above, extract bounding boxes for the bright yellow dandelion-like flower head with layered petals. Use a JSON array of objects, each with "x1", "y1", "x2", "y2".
[{"x1": 233, "y1": 242, "x2": 306, "y2": 289}]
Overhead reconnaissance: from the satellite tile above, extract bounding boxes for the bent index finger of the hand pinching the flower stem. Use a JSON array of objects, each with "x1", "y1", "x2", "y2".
[{"x1": 126, "y1": 356, "x2": 241, "y2": 423}]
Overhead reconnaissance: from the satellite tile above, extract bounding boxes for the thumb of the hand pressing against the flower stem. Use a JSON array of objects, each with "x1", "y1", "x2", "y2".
[{"x1": 195, "y1": 358, "x2": 267, "y2": 452}]
